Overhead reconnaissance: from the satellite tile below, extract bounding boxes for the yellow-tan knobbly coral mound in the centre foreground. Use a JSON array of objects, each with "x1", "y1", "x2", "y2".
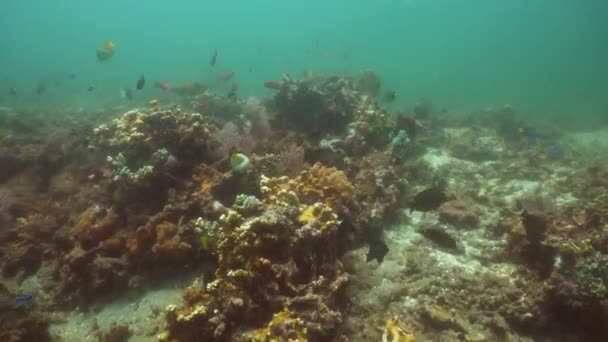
[{"x1": 163, "y1": 164, "x2": 356, "y2": 341}]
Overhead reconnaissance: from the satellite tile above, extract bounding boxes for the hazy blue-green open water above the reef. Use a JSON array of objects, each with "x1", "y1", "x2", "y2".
[{"x1": 0, "y1": 0, "x2": 608, "y2": 118}]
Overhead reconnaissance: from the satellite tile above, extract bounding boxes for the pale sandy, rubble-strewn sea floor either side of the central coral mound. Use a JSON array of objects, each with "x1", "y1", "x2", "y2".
[{"x1": 0, "y1": 93, "x2": 608, "y2": 342}]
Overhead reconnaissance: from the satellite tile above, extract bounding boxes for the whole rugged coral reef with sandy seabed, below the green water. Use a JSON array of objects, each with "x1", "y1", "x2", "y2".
[{"x1": 0, "y1": 71, "x2": 608, "y2": 342}]
